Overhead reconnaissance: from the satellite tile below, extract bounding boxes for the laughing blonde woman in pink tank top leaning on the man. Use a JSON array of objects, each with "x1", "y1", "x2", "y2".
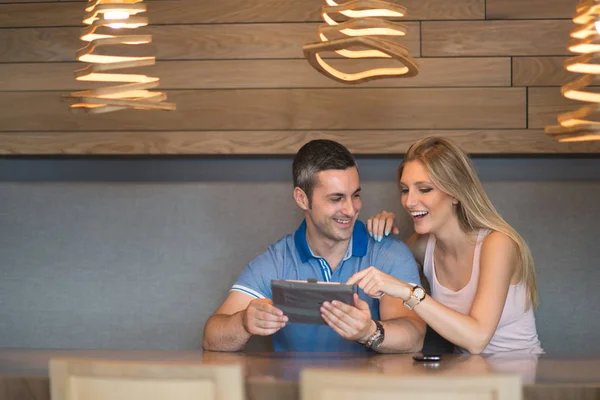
[{"x1": 348, "y1": 137, "x2": 543, "y2": 354}]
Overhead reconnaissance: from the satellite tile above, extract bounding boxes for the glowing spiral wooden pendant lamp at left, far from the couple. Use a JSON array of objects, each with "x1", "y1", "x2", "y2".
[{"x1": 65, "y1": 0, "x2": 175, "y2": 114}]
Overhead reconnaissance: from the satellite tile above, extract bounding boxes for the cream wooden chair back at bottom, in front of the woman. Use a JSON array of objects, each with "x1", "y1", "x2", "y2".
[{"x1": 300, "y1": 368, "x2": 522, "y2": 400}]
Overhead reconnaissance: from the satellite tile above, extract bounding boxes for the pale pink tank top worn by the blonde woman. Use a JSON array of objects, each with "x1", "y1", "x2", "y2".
[{"x1": 423, "y1": 229, "x2": 544, "y2": 354}]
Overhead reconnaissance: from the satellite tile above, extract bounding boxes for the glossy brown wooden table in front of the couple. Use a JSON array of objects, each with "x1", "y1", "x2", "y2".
[{"x1": 0, "y1": 349, "x2": 600, "y2": 400}]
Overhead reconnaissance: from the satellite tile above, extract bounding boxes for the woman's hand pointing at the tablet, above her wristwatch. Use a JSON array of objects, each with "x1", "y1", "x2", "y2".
[{"x1": 346, "y1": 267, "x2": 412, "y2": 301}]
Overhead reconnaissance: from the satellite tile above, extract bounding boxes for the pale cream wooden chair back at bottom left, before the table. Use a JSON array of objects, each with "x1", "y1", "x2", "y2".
[{"x1": 50, "y1": 359, "x2": 244, "y2": 400}]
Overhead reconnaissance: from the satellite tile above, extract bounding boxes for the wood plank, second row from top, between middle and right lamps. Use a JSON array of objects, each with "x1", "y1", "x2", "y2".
[{"x1": 422, "y1": 20, "x2": 573, "y2": 57}]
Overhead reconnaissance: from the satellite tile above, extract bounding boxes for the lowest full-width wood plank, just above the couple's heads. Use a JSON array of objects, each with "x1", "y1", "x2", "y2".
[{"x1": 0, "y1": 130, "x2": 600, "y2": 155}]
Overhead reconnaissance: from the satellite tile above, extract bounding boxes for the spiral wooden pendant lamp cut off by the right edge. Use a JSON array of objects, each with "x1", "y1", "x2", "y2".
[{"x1": 545, "y1": 0, "x2": 600, "y2": 142}]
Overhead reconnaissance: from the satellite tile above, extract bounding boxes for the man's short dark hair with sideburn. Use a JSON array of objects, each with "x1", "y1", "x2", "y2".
[{"x1": 292, "y1": 139, "x2": 356, "y2": 205}]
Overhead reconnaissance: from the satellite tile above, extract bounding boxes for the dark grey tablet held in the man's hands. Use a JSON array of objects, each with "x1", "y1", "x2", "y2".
[{"x1": 271, "y1": 280, "x2": 355, "y2": 324}]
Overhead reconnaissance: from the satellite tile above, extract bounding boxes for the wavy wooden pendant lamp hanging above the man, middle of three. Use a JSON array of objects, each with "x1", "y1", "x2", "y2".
[{"x1": 303, "y1": 0, "x2": 419, "y2": 83}]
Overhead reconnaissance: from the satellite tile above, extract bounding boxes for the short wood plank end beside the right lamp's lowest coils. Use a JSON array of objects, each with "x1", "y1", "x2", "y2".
[{"x1": 528, "y1": 87, "x2": 584, "y2": 129}]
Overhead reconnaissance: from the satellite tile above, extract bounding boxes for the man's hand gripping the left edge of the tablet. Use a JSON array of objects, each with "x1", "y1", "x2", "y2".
[{"x1": 242, "y1": 299, "x2": 288, "y2": 336}]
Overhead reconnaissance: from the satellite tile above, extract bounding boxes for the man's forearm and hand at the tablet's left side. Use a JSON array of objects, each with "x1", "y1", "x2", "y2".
[{"x1": 202, "y1": 291, "x2": 287, "y2": 351}]
